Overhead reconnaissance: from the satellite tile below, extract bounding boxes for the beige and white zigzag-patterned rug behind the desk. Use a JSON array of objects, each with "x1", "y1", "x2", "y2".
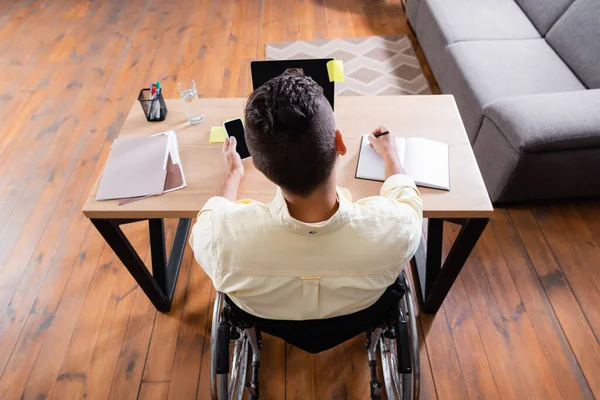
[{"x1": 266, "y1": 35, "x2": 431, "y2": 96}]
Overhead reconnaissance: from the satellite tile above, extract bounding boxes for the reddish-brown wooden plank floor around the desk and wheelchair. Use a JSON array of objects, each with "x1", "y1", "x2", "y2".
[{"x1": 0, "y1": 0, "x2": 600, "y2": 400}]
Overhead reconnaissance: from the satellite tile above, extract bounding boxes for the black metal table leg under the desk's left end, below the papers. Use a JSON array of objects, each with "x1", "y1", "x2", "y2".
[{"x1": 91, "y1": 218, "x2": 191, "y2": 312}]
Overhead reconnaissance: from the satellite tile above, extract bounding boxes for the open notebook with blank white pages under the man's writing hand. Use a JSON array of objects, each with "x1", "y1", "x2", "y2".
[{"x1": 356, "y1": 135, "x2": 450, "y2": 190}]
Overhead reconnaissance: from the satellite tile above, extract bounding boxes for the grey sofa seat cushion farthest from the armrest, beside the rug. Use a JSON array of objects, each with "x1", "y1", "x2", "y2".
[{"x1": 409, "y1": 0, "x2": 540, "y2": 80}]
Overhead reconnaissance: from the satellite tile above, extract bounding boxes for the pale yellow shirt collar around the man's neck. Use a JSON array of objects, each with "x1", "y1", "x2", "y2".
[{"x1": 269, "y1": 187, "x2": 350, "y2": 237}]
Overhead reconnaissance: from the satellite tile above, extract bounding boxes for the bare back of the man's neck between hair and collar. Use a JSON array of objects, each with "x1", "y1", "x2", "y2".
[{"x1": 283, "y1": 179, "x2": 339, "y2": 223}]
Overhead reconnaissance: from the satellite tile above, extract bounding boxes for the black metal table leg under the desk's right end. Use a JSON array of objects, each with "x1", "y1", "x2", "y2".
[{"x1": 413, "y1": 218, "x2": 489, "y2": 313}]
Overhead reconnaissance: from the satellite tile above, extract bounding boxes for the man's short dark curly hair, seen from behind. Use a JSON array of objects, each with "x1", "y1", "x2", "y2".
[{"x1": 245, "y1": 70, "x2": 337, "y2": 196}]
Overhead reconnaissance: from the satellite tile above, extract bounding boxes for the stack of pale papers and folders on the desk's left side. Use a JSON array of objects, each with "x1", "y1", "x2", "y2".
[{"x1": 96, "y1": 131, "x2": 186, "y2": 204}]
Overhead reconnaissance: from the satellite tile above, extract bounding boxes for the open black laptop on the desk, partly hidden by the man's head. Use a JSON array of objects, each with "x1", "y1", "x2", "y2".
[{"x1": 250, "y1": 58, "x2": 335, "y2": 109}]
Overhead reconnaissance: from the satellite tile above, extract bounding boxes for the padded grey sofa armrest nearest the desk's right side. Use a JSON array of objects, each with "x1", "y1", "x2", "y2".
[{"x1": 483, "y1": 89, "x2": 600, "y2": 153}]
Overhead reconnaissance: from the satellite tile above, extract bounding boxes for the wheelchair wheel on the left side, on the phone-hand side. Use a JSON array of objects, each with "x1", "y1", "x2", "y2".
[{"x1": 210, "y1": 293, "x2": 252, "y2": 400}]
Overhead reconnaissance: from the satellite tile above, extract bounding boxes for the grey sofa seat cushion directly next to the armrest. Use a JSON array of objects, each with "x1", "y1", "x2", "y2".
[{"x1": 437, "y1": 39, "x2": 585, "y2": 143}]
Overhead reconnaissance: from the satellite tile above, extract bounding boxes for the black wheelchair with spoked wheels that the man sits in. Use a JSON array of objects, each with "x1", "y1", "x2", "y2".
[{"x1": 210, "y1": 271, "x2": 419, "y2": 400}]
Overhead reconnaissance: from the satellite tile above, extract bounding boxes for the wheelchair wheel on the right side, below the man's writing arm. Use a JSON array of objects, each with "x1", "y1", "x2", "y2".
[{"x1": 379, "y1": 271, "x2": 420, "y2": 400}]
